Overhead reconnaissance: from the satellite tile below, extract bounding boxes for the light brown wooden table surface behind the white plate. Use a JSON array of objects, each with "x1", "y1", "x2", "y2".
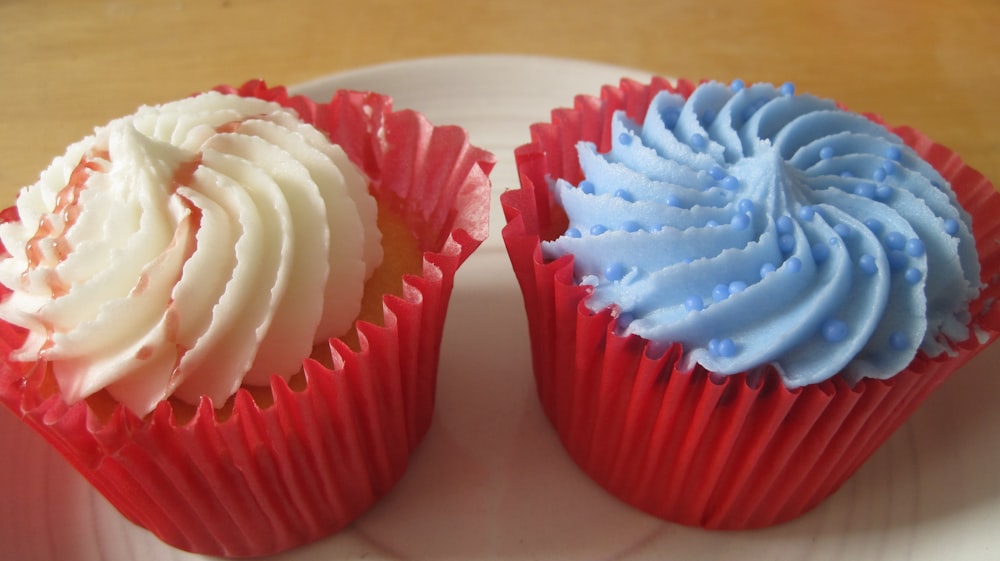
[{"x1": 0, "y1": 0, "x2": 1000, "y2": 201}]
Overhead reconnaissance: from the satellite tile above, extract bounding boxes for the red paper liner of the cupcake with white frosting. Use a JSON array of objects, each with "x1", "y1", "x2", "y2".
[{"x1": 0, "y1": 81, "x2": 494, "y2": 557}]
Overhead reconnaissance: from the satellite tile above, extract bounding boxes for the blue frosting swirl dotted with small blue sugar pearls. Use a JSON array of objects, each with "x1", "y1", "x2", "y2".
[{"x1": 543, "y1": 82, "x2": 980, "y2": 388}]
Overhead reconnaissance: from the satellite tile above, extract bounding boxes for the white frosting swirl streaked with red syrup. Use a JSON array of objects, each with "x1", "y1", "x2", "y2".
[{"x1": 0, "y1": 92, "x2": 382, "y2": 415}]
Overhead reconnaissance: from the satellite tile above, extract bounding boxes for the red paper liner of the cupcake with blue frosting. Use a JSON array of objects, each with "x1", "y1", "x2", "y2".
[{"x1": 501, "y1": 78, "x2": 1000, "y2": 529}]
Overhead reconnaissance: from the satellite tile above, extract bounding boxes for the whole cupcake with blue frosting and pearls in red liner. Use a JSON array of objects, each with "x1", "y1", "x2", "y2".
[{"x1": 501, "y1": 78, "x2": 1000, "y2": 529}]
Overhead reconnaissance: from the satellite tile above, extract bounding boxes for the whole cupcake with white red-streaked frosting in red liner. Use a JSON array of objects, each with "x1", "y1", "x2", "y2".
[{"x1": 0, "y1": 81, "x2": 494, "y2": 557}]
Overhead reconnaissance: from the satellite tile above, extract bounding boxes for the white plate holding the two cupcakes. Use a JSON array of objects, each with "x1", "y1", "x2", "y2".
[{"x1": 0, "y1": 56, "x2": 1000, "y2": 561}]
